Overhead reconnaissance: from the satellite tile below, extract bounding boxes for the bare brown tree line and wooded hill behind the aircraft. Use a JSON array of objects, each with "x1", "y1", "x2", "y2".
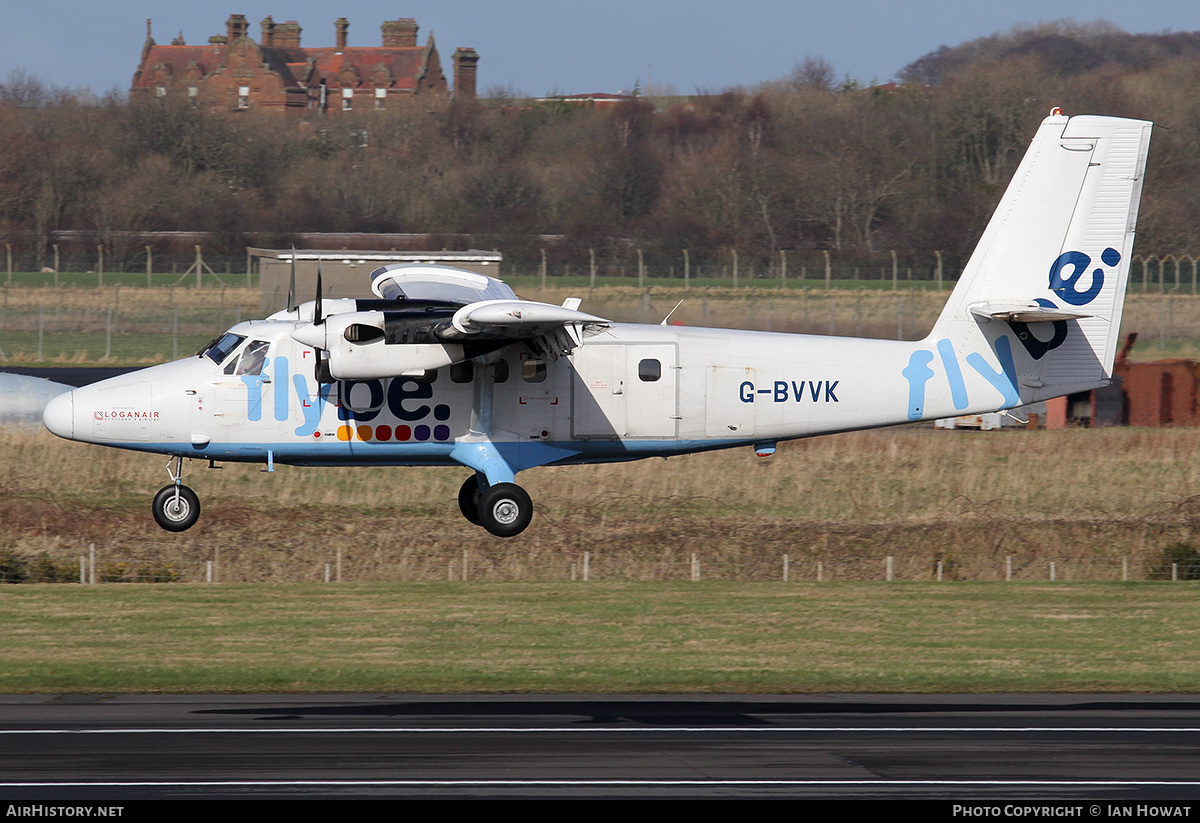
[{"x1": 0, "y1": 24, "x2": 1200, "y2": 273}]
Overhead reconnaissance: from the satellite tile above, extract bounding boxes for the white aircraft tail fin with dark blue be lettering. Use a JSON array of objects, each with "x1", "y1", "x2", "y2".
[{"x1": 928, "y1": 109, "x2": 1151, "y2": 406}]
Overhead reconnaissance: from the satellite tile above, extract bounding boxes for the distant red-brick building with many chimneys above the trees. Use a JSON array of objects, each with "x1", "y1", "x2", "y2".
[{"x1": 131, "y1": 14, "x2": 479, "y2": 116}]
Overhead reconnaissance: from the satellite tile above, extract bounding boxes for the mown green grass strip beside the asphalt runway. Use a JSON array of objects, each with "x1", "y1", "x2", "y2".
[{"x1": 0, "y1": 583, "x2": 1200, "y2": 693}]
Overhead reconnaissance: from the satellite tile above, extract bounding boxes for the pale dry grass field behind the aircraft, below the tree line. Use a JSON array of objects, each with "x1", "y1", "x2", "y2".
[{"x1": 0, "y1": 281, "x2": 1200, "y2": 364}]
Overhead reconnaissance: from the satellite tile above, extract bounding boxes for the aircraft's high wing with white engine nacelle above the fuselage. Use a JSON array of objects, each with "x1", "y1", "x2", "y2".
[{"x1": 292, "y1": 264, "x2": 611, "y2": 380}]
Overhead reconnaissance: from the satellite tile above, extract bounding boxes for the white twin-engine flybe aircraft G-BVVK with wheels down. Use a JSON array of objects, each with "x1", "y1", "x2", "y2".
[{"x1": 44, "y1": 109, "x2": 1151, "y2": 537}]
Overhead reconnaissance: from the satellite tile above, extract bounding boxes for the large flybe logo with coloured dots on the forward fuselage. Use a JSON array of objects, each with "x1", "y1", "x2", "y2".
[{"x1": 241, "y1": 356, "x2": 450, "y2": 440}]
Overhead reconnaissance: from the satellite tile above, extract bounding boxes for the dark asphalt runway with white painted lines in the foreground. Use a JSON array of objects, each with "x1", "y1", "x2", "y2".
[{"x1": 0, "y1": 695, "x2": 1200, "y2": 801}]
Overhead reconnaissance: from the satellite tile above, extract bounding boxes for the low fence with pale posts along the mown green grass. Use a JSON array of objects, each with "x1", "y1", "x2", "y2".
[{"x1": 7, "y1": 543, "x2": 1200, "y2": 584}]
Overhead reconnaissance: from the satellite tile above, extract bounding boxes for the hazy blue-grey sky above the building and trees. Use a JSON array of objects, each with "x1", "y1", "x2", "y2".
[{"x1": 0, "y1": 0, "x2": 1200, "y2": 95}]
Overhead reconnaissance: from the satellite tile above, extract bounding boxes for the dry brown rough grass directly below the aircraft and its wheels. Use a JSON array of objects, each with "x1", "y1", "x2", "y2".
[{"x1": 9, "y1": 427, "x2": 1200, "y2": 581}]
